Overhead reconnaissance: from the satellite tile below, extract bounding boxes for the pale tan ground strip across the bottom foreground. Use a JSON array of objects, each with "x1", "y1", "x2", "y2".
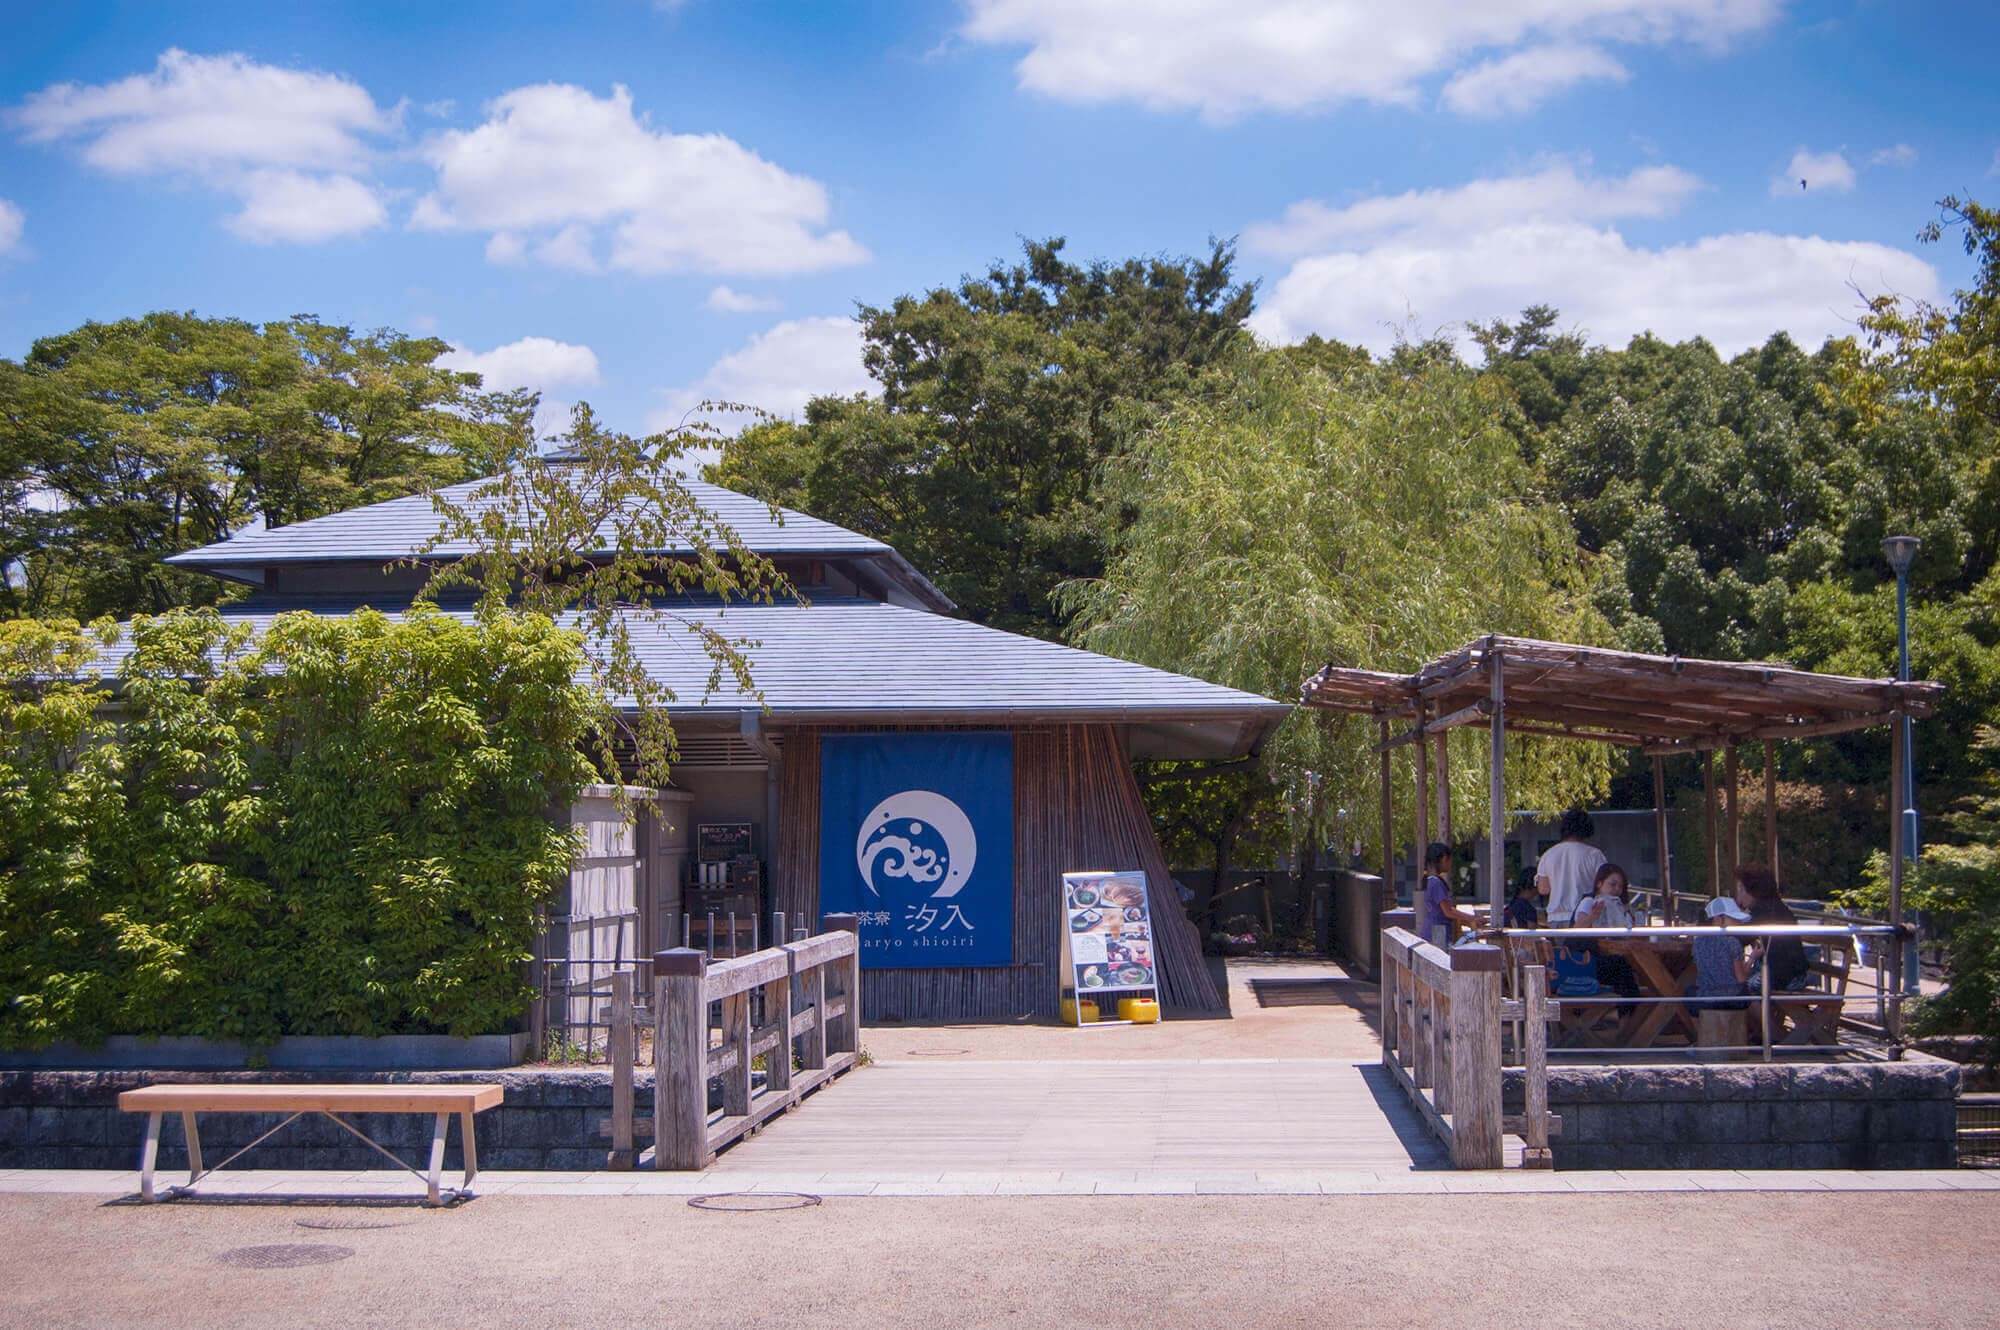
[{"x1": 0, "y1": 1192, "x2": 2000, "y2": 1330}]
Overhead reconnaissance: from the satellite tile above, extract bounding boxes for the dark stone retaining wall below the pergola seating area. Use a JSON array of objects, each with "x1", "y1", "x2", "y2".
[{"x1": 1502, "y1": 1052, "x2": 1958, "y2": 1168}]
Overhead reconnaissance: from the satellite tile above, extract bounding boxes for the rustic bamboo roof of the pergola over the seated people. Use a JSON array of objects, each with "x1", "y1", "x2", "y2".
[{"x1": 1300, "y1": 636, "x2": 1944, "y2": 754}]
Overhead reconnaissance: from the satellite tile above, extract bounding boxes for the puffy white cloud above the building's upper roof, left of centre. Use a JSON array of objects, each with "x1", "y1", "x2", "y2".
[{"x1": 410, "y1": 84, "x2": 868, "y2": 276}]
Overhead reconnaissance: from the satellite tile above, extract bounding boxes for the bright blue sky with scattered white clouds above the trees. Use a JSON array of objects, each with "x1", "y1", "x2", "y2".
[{"x1": 0, "y1": 0, "x2": 2000, "y2": 430}]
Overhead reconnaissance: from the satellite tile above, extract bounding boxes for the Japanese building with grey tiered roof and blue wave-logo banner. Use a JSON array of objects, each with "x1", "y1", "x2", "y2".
[{"x1": 152, "y1": 472, "x2": 1290, "y2": 1020}]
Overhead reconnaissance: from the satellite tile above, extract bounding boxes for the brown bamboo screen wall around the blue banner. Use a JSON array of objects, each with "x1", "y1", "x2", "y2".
[{"x1": 774, "y1": 726, "x2": 1222, "y2": 1020}]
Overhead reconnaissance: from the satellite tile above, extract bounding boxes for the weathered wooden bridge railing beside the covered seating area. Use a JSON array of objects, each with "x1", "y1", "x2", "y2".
[{"x1": 1382, "y1": 924, "x2": 1562, "y2": 1168}]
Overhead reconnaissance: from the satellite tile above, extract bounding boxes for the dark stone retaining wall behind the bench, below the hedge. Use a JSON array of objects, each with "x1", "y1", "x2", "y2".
[{"x1": 0, "y1": 1068, "x2": 652, "y2": 1170}]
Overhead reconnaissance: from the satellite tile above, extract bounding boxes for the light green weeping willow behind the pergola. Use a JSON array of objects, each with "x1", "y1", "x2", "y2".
[{"x1": 1064, "y1": 338, "x2": 1608, "y2": 868}]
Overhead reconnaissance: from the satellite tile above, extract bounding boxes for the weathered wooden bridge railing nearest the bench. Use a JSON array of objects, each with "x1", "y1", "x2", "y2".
[{"x1": 608, "y1": 914, "x2": 862, "y2": 1168}]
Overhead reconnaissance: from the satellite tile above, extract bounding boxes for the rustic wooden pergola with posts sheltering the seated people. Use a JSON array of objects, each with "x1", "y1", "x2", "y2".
[{"x1": 1300, "y1": 636, "x2": 1944, "y2": 928}]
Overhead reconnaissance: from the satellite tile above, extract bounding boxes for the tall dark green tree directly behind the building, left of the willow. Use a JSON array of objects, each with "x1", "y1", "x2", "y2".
[{"x1": 708, "y1": 240, "x2": 1252, "y2": 638}]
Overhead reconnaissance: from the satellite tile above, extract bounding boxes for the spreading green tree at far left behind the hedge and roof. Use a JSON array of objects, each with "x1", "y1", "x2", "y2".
[{"x1": 0, "y1": 312, "x2": 534, "y2": 618}]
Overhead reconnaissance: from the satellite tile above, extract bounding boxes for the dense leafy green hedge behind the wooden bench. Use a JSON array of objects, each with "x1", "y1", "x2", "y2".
[{"x1": 0, "y1": 612, "x2": 602, "y2": 1048}]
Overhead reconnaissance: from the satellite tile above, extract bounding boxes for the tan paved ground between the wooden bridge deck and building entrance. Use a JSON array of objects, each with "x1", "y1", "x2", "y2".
[{"x1": 862, "y1": 960, "x2": 1382, "y2": 1062}]
